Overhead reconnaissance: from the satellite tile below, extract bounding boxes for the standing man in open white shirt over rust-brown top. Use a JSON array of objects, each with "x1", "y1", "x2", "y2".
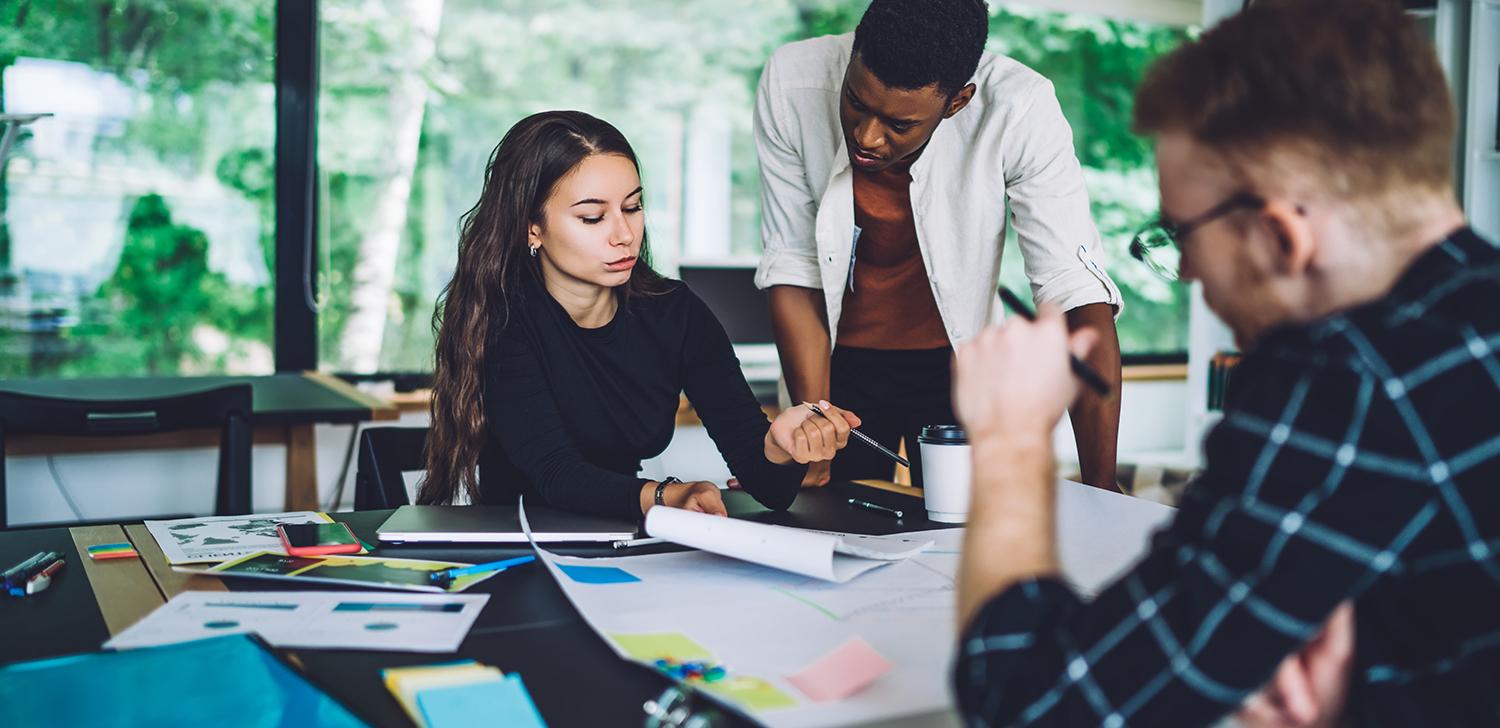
[{"x1": 755, "y1": 0, "x2": 1121, "y2": 489}]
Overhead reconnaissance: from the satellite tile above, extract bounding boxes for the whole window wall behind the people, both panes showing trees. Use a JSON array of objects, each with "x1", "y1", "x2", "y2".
[{"x1": 0, "y1": 0, "x2": 1190, "y2": 377}]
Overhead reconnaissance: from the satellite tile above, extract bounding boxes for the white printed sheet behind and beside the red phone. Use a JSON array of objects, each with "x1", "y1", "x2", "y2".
[{"x1": 146, "y1": 510, "x2": 333, "y2": 564}]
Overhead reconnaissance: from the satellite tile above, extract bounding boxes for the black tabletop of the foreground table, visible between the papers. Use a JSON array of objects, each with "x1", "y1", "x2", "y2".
[{"x1": 0, "y1": 483, "x2": 950, "y2": 726}]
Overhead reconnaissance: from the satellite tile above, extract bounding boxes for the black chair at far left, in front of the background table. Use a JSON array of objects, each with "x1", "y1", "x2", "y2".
[{"x1": 0, "y1": 384, "x2": 251, "y2": 528}]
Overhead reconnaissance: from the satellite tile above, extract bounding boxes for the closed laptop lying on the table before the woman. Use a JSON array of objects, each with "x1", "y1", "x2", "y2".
[{"x1": 375, "y1": 503, "x2": 638, "y2": 543}]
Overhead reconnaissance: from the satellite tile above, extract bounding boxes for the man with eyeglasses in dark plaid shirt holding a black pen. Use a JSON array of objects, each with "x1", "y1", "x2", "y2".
[{"x1": 954, "y1": 0, "x2": 1500, "y2": 726}]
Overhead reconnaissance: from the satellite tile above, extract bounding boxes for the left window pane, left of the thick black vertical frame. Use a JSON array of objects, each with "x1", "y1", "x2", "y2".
[{"x1": 0, "y1": 0, "x2": 275, "y2": 378}]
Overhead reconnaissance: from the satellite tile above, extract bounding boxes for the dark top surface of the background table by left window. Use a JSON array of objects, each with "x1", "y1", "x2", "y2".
[{"x1": 0, "y1": 374, "x2": 387, "y2": 425}]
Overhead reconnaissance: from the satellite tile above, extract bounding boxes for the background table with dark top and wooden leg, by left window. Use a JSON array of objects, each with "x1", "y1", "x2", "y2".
[{"x1": 0, "y1": 372, "x2": 401, "y2": 510}]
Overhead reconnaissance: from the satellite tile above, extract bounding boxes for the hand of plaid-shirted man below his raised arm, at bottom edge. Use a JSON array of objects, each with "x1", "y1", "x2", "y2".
[{"x1": 1235, "y1": 602, "x2": 1355, "y2": 728}]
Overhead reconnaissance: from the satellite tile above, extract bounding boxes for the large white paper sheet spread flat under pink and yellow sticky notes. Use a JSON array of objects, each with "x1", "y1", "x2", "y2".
[{"x1": 525, "y1": 482, "x2": 1173, "y2": 726}]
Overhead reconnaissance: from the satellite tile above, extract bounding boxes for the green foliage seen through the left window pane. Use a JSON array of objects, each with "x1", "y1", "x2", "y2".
[{"x1": 0, "y1": 0, "x2": 275, "y2": 377}]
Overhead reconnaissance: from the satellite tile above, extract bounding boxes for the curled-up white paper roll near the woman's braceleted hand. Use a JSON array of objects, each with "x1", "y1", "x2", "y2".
[{"x1": 647, "y1": 507, "x2": 933, "y2": 584}]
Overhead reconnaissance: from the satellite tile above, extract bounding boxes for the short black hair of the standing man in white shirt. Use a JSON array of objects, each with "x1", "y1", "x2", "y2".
[{"x1": 854, "y1": 0, "x2": 990, "y2": 96}]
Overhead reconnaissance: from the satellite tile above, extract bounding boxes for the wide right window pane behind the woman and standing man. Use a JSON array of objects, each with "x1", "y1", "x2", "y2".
[{"x1": 320, "y1": 0, "x2": 1188, "y2": 372}]
